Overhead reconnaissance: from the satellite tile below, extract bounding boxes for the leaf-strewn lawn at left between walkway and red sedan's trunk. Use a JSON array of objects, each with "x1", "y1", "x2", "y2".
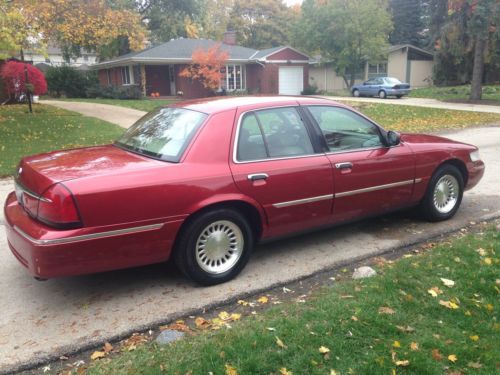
[{"x1": 0, "y1": 104, "x2": 124, "y2": 176}]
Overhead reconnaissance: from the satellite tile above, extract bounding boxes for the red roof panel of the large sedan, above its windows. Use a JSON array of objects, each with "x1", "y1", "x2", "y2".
[{"x1": 169, "y1": 96, "x2": 343, "y2": 114}]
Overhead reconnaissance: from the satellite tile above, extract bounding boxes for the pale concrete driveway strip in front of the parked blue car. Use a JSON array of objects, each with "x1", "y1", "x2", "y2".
[{"x1": 321, "y1": 96, "x2": 500, "y2": 114}]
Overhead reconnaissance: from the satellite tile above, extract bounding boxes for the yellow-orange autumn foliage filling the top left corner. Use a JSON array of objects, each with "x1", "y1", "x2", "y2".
[{"x1": 1, "y1": 0, "x2": 146, "y2": 59}]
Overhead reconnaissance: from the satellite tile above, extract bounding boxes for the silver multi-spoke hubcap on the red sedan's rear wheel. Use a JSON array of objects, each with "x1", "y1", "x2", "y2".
[{"x1": 196, "y1": 220, "x2": 245, "y2": 274}]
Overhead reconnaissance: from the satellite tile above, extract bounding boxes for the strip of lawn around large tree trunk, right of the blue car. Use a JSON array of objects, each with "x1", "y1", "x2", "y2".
[{"x1": 410, "y1": 85, "x2": 500, "y2": 104}]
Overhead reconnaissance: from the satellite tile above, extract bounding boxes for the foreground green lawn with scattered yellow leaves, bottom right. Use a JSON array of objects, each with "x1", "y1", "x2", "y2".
[{"x1": 84, "y1": 226, "x2": 500, "y2": 375}]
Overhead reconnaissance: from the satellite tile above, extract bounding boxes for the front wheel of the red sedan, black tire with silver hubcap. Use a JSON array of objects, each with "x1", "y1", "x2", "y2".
[{"x1": 419, "y1": 164, "x2": 464, "y2": 221}]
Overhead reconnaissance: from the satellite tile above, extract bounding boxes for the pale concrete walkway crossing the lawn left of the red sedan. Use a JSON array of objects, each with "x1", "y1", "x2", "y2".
[{"x1": 40, "y1": 100, "x2": 147, "y2": 128}]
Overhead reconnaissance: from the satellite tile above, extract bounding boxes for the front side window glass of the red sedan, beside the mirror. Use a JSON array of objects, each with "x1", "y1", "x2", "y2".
[{"x1": 308, "y1": 106, "x2": 383, "y2": 152}]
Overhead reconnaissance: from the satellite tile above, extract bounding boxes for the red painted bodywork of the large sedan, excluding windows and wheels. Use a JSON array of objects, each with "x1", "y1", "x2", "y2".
[{"x1": 4, "y1": 97, "x2": 484, "y2": 278}]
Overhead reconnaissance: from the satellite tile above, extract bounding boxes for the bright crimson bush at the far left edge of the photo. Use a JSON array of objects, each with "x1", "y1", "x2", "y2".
[{"x1": 0, "y1": 61, "x2": 47, "y2": 99}]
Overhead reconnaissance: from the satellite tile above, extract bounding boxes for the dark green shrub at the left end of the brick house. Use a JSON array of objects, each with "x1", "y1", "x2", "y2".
[{"x1": 46, "y1": 66, "x2": 97, "y2": 98}]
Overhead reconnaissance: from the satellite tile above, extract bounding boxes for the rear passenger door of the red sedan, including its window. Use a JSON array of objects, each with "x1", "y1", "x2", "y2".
[{"x1": 230, "y1": 106, "x2": 333, "y2": 236}]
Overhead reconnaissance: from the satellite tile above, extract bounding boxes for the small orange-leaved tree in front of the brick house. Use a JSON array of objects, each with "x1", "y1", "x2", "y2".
[{"x1": 180, "y1": 44, "x2": 229, "y2": 91}]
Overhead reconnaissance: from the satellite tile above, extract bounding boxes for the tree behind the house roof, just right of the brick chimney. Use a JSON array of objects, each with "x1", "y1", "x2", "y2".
[{"x1": 228, "y1": 0, "x2": 293, "y2": 49}]
